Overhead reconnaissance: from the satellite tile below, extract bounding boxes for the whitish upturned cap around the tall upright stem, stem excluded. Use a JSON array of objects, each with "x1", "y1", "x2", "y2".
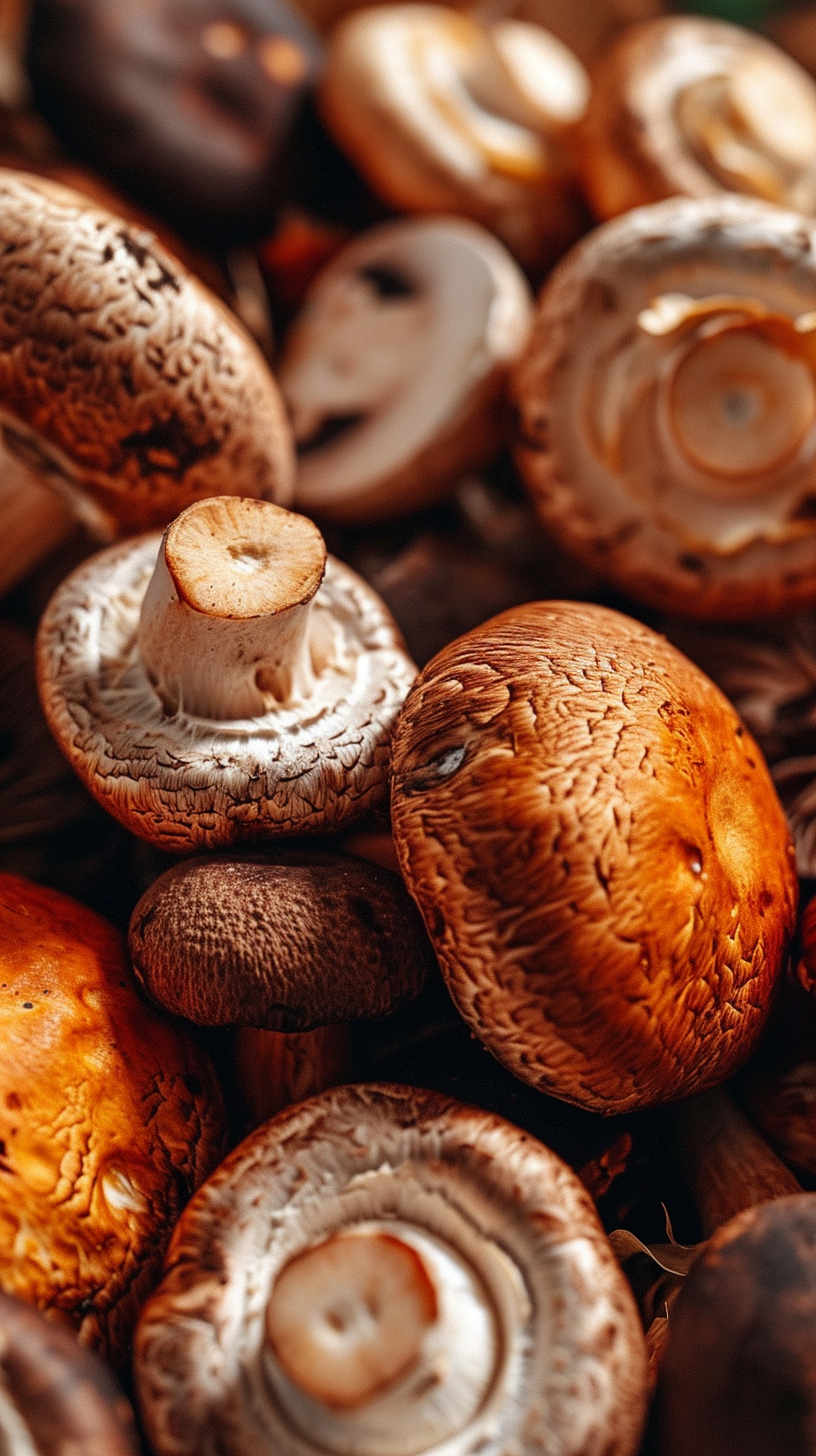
[{"x1": 38, "y1": 534, "x2": 415, "y2": 853}]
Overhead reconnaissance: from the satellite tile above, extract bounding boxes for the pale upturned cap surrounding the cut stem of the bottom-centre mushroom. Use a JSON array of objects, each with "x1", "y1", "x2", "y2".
[{"x1": 136, "y1": 1086, "x2": 646, "y2": 1456}]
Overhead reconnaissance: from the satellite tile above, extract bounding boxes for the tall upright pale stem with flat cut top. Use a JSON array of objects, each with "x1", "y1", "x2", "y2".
[{"x1": 138, "y1": 496, "x2": 326, "y2": 721}]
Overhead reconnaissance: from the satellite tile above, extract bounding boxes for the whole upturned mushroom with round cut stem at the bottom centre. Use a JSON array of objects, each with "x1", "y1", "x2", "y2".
[{"x1": 136, "y1": 1086, "x2": 646, "y2": 1456}]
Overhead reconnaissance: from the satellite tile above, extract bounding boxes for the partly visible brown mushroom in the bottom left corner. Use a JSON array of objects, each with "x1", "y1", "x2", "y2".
[{"x1": 0, "y1": 1293, "x2": 140, "y2": 1456}]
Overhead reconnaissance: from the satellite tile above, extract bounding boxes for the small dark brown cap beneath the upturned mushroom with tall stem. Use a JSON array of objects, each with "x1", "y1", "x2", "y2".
[{"x1": 128, "y1": 849, "x2": 434, "y2": 1031}]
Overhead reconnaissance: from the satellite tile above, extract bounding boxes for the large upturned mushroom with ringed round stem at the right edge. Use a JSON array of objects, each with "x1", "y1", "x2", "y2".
[{"x1": 513, "y1": 197, "x2": 816, "y2": 620}]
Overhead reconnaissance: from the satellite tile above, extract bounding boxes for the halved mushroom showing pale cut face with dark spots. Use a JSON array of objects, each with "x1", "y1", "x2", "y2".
[{"x1": 280, "y1": 218, "x2": 532, "y2": 521}]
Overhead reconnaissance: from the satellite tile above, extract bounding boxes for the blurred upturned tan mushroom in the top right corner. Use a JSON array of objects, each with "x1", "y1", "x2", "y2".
[{"x1": 576, "y1": 16, "x2": 816, "y2": 217}]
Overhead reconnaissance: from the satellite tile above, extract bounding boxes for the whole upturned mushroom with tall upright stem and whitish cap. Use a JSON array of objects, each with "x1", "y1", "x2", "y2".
[{"x1": 38, "y1": 496, "x2": 415, "y2": 853}]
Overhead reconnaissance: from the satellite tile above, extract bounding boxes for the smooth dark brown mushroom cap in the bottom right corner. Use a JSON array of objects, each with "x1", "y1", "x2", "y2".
[{"x1": 659, "y1": 1194, "x2": 816, "y2": 1456}]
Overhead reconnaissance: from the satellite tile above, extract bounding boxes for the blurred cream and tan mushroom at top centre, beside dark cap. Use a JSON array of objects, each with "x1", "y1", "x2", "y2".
[{"x1": 319, "y1": 4, "x2": 589, "y2": 266}]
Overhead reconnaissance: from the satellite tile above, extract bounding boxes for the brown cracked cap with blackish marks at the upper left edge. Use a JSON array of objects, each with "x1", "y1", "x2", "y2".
[{"x1": 0, "y1": 169, "x2": 293, "y2": 533}]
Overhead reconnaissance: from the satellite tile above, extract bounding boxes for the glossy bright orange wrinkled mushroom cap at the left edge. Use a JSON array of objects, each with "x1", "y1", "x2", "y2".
[{"x1": 0, "y1": 875, "x2": 224, "y2": 1363}]
